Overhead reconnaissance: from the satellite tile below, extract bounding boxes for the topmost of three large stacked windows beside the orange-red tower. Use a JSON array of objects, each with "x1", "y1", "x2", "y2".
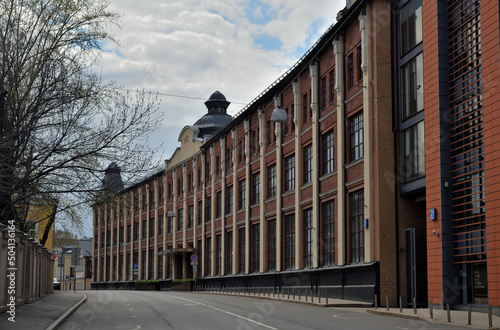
[{"x1": 399, "y1": 0, "x2": 422, "y2": 55}]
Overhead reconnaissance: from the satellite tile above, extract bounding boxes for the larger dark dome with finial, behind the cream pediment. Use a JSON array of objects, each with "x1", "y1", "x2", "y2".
[{"x1": 193, "y1": 91, "x2": 233, "y2": 138}]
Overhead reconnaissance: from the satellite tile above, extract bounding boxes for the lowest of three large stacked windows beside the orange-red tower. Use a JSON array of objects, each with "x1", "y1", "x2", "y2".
[{"x1": 402, "y1": 121, "x2": 425, "y2": 182}]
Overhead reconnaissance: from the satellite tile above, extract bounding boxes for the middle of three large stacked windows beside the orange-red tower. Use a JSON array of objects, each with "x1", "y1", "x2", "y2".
[{"x1": 401, "y1": 53, "x2": 424, "y2": 120}]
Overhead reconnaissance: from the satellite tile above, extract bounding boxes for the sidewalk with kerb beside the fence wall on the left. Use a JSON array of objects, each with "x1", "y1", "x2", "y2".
[{"x1": 0, "y1": 291, "x2": 87, "y2": 330}]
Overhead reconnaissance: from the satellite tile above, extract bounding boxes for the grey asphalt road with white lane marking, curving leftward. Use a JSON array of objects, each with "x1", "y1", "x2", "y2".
[{"x1": 60, "y1": 291, "x2": 470, "y2": 330}]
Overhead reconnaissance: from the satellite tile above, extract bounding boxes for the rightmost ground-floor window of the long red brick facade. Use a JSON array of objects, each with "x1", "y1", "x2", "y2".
[{"x1": 349, "y1": 191, "x2": 365, "y2": 263}]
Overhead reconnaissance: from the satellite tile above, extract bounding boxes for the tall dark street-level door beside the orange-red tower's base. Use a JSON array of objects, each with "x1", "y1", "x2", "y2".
[{"x1": 405, "y1": 228, "x2": 427, "y2": 306}]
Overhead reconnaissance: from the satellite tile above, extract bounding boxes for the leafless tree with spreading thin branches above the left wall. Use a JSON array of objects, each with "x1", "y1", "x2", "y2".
[{"x1": 0, "y1": 0, "x2": 160, "y2": 240}]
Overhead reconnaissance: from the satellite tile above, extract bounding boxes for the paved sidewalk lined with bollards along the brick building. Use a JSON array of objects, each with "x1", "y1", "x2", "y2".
[{"x1": 195, "y1": 291, "x2": 500, "y2": 330}]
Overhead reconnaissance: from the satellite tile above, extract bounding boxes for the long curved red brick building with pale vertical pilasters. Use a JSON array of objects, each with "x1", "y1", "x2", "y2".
[{"x1": 93, "y1": 1, "x2": 398, "y2": 304}]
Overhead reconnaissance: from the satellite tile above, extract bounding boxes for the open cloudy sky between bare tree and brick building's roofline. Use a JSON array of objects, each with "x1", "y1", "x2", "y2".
[{"x1": 81, "y1": 0, "x2": 346, "y2": 237}]
